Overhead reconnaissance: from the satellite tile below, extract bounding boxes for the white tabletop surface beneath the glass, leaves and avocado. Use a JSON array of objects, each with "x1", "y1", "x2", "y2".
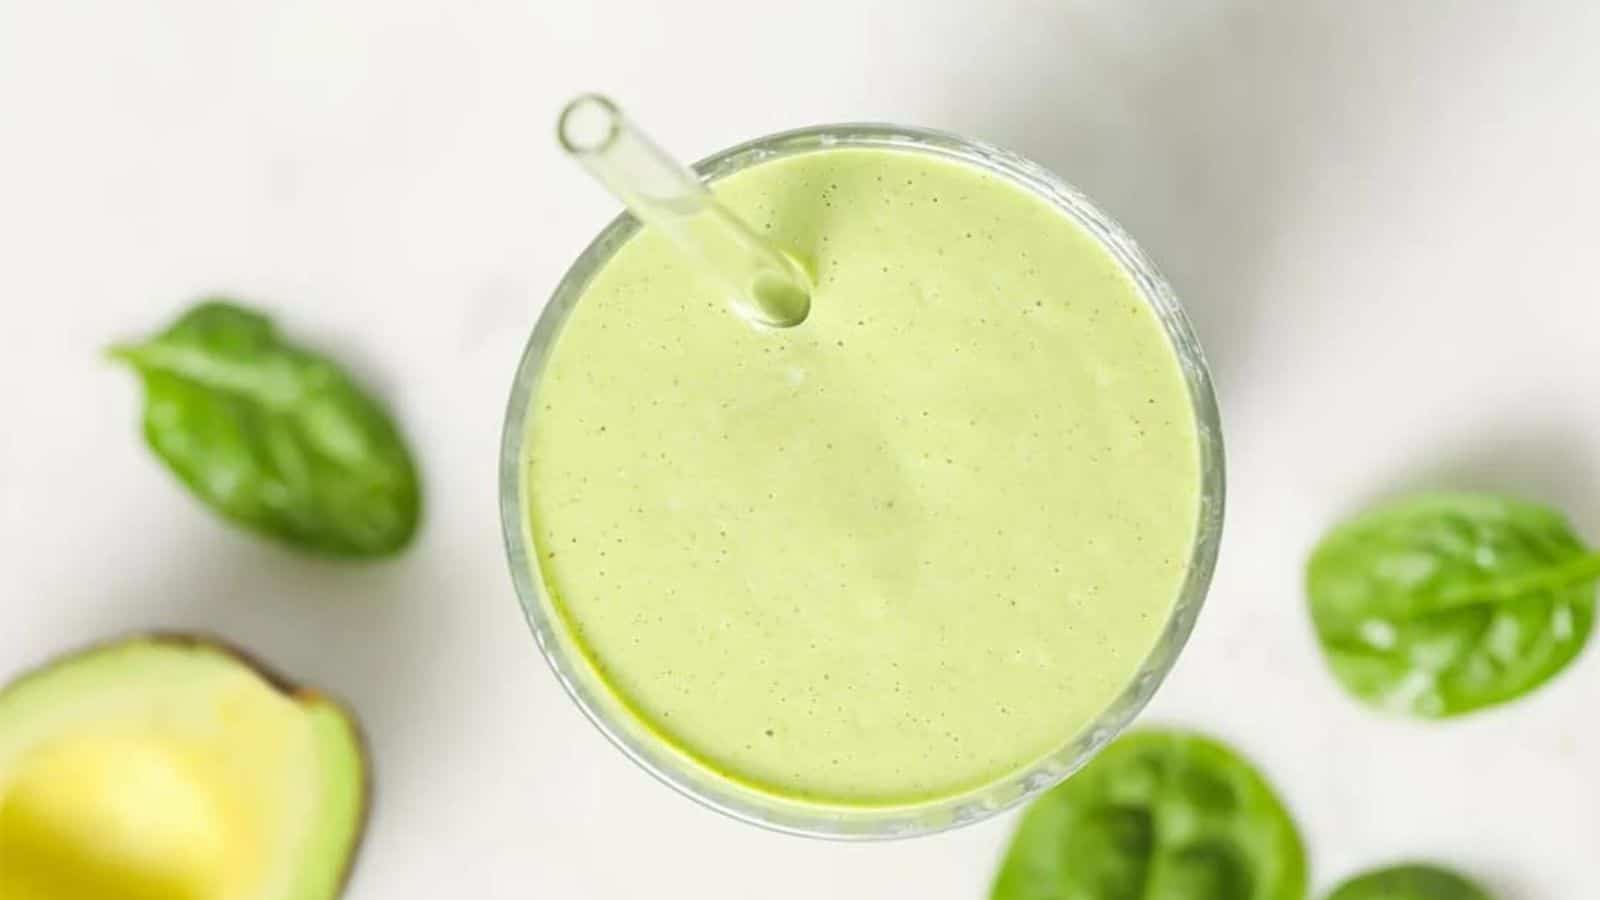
[{"x1": 0, "y1": 0, "x2": 1600, "y2": 900}]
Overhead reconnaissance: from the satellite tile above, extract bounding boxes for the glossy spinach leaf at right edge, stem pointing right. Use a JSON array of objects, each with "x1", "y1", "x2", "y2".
[{"x1": 1306, "y1": 493, "x2": 1600, "y2": 717}]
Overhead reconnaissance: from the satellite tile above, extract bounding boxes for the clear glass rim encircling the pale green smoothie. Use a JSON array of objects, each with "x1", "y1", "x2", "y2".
[{"x1": 499, "y1": 123, "x2": 1226, "y2": 841}]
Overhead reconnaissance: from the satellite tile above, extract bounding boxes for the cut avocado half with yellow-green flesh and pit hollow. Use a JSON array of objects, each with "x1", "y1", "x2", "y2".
[{"x1": 0, "y1": 636, "x2": 368, "y2": 900}]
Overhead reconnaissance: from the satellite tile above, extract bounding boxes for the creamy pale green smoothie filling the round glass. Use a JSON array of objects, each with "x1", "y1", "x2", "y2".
[{"x1": 523, "y1": 147, "x2": 1200, "y2": 807}]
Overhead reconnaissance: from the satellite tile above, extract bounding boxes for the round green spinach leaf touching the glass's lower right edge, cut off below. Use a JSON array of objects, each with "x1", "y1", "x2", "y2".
[{"x1": 990, "y1": 730, "x2": 1306, "y2": 900}]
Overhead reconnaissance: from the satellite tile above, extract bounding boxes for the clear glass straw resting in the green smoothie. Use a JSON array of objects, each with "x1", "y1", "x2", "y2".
[{"x1": 557, "y1": 94, "x2": 811, "y2": 328}]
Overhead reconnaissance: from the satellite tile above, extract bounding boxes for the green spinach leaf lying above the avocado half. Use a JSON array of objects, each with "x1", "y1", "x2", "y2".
[{"x1": 110, "y1": 299, "x2": 421, "y2": 557}]
